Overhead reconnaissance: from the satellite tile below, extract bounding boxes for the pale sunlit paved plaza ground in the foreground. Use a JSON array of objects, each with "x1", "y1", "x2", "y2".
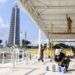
[{"x1": 0, "y1": 59, "x2": 75, "y2": 75}]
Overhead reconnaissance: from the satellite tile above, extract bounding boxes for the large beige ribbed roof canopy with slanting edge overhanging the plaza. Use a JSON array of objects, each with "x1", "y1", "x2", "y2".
[{"x1": 20, "y1": 0, "x2": 75, "y2": 39}]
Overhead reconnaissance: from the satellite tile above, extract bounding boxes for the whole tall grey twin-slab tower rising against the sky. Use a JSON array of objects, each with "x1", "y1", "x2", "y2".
[{"x1": 8, "y1": 5, "x2": 20, "y2": 46}]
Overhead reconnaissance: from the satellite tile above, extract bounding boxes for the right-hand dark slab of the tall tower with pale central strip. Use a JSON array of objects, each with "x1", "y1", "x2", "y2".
[{"x1": 15, "y1": 5, "x2": 20, "y2": 45}]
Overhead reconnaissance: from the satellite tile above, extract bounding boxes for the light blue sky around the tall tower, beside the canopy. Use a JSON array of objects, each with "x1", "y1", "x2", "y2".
[{"x1": 0, "y1": 0, "x2": 46, "y2": 43}]
